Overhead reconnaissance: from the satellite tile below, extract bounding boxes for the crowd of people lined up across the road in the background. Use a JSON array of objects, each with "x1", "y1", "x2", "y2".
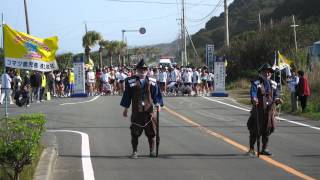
[{"x1": 0, "y1": 66, "x2": 214, "y2": 106}]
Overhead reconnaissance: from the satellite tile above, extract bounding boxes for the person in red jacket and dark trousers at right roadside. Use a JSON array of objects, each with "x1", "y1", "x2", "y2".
[{"x1": 297, "y1": 71, "x2": 311, "y2": 112}]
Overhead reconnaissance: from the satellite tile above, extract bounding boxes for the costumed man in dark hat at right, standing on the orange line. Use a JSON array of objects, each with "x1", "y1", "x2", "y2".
[{"x1": 247, "y1": 63, "x2": 282, "y2": 156}]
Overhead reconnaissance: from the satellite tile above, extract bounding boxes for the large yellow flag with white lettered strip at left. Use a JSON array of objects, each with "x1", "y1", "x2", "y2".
[{"x1": 3, "y1": 25, "x2": 58, "y2": 72}]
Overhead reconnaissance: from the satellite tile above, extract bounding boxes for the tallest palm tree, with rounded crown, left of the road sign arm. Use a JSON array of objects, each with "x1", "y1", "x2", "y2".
[{"x1": 82, "y1": 31, "x2": 102, "y2": 64}]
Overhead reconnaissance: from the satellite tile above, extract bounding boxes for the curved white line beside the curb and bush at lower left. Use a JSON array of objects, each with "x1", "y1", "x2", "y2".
[{"x1": 47, "y1": 130, "x2": 95, "y2": 180}]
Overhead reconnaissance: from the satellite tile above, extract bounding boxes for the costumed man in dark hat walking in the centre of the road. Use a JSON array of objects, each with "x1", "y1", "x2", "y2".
[{"x1": 120, "y1": 59, "x2": 163, "y2": 159}]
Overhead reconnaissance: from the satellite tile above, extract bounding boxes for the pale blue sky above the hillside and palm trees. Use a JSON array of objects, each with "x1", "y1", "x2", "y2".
[{"x1": 0, "y1": 0, "x2": 231, "y2": 53}]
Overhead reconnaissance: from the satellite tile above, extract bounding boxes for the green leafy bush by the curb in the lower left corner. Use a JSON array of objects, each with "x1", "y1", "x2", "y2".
[{"x1": 0, "y1": 114, "x2": 45, "y2": 180}]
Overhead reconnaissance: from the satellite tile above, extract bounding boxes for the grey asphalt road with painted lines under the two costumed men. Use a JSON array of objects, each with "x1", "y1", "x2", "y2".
[{"x1": 0, "y1": 96, "x2": 320, "y2": 180}]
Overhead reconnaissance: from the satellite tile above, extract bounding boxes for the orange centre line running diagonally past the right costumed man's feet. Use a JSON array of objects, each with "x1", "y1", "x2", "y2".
[{"x1": 163, "y1": 106, "x2": 315, "y2": 180}]
